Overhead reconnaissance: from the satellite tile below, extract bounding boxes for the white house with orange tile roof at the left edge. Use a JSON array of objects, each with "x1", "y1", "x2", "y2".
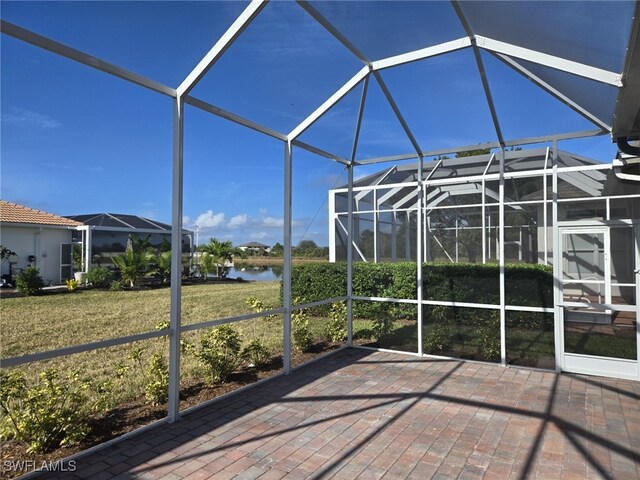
[{"x1": 0, "y1": 200, "x2": 82, "y2": 284}]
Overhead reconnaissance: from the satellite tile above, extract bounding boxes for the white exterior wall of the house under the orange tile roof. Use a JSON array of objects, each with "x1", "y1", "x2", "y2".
[{"x1": 1, "y1": 225, "x2": 73, "y2": 285}]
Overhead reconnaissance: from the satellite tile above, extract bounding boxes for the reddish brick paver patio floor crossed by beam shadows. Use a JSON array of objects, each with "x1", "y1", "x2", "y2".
[{"x1": 47, "y1": 349, "x2": 640, "y2": 480}]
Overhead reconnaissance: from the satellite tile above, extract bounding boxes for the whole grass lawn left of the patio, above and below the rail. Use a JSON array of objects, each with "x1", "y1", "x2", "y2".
[{"x1": 0, "y1": 282, "x2": 282, "y2": 402}]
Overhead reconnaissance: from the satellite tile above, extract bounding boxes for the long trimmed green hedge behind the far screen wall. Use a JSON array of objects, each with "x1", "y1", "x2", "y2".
[{"x1": 291, "y1": 262, "x2": 553, "y2": 318}]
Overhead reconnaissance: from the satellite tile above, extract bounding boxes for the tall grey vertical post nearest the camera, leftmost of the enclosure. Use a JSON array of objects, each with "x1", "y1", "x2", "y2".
[{"x1": 167, "y1": 96, "x2": 184, "y2": 422}]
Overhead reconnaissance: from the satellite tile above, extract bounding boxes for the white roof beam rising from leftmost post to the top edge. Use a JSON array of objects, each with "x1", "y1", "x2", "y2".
[{"x1": 177, "y1": 0, "x2": 267, "y2": 96}]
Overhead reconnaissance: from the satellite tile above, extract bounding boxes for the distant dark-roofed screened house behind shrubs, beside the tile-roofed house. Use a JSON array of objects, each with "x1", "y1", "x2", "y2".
[{"x1": 67, "y1": 213, "x2": 193, "y2": 266}]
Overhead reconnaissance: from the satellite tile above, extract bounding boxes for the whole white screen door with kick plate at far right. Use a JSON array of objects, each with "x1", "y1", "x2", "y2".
[{"x1": 556, "y1": 225, "x2": 640, "y2": 379}]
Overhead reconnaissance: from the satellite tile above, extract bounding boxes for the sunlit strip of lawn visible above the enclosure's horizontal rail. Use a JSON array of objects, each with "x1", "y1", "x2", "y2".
[{"x1": 0, "y1": 282, "x2": 280, "y2": 358}]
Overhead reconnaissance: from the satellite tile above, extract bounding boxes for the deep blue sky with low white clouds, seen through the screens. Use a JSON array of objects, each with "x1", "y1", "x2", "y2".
[{"x1": 0, "y1": 2, "x2": 615, "y2": 245}]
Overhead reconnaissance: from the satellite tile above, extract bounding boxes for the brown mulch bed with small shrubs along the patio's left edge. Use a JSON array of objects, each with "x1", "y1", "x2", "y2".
[{"x1": 0, "y1": 342, "x2": 340, "y2": 479}]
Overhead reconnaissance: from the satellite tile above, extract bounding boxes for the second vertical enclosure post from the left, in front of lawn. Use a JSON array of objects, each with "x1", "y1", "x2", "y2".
[{"x1": 282, "y1": 140, "x2": 293, "y2": 374}]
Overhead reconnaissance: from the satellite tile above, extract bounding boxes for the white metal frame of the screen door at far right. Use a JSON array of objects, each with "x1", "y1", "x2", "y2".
[{"x1": 554, "y1": 221, "x2": 640, "y2": 380}]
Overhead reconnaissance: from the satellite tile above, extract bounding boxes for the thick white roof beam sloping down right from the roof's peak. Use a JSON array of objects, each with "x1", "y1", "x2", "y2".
[{"x1": 475, "y1": 35, "x2": 623, "y2": 87}]
